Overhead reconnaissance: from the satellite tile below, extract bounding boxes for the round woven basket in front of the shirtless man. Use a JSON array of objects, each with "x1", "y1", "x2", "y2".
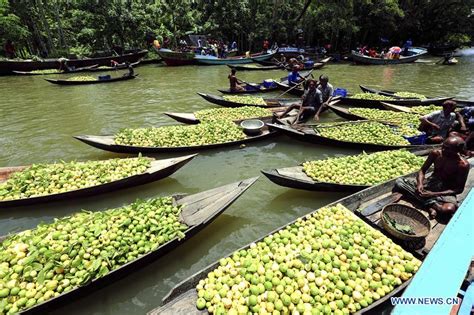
[{"x1": 381, "y1": 203, "x2": 431, "y2": 241}]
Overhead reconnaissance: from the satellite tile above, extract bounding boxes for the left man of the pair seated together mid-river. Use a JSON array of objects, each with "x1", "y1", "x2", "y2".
[{"x1": 278, "y1": 79, "x2": 323, "y2": 123}]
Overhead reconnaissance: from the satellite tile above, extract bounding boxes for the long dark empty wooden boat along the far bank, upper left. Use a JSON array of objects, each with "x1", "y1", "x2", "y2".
[{"x1": 0, "y1": 50, "x2": 148, "y2": 75}]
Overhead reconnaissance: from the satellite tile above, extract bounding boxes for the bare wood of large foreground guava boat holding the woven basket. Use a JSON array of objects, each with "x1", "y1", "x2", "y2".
[{"x1": 148, "y1": 162, "x2": 474, "y2": 315}]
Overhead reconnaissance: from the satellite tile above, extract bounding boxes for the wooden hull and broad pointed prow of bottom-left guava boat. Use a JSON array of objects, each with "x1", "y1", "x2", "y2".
[{"x1": 0, "y1": 177, "x2": 258, "y2": 314}]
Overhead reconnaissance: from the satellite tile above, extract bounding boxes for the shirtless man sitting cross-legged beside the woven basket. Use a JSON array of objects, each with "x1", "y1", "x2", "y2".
[{"x1": 394, "y1": 136, "x2": 470, "y2": 219}]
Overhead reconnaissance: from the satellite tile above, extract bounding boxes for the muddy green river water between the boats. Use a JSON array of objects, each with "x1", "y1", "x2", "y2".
[{"x1": 0, "y1": 57, "x2": 474, "y2": 314}]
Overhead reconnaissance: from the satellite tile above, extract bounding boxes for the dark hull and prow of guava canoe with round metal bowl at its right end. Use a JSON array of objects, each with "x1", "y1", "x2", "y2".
[{"x1": 74, "y1": 125, "x2": 277, "y2": 153}]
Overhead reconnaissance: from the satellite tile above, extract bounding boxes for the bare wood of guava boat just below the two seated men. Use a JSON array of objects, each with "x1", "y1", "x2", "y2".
[{"x1": 267, "y1": 121, "x2": 436, "y2": 151}]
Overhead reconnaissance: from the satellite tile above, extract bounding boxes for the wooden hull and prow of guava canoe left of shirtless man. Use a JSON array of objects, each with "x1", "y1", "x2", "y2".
[{"x1": 261, "y1": 149, "x2": 431, "y2": 192}]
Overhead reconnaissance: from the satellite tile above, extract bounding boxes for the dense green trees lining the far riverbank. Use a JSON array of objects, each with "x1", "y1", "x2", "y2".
[{"x1": 0, "y1": 0, "x2": 474, "y2": 56}]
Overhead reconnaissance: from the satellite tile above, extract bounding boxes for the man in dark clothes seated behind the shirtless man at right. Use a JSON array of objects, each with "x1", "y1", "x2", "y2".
[{"x1": 419, "y1": 100, "x2": 466, "y2": 143}]
